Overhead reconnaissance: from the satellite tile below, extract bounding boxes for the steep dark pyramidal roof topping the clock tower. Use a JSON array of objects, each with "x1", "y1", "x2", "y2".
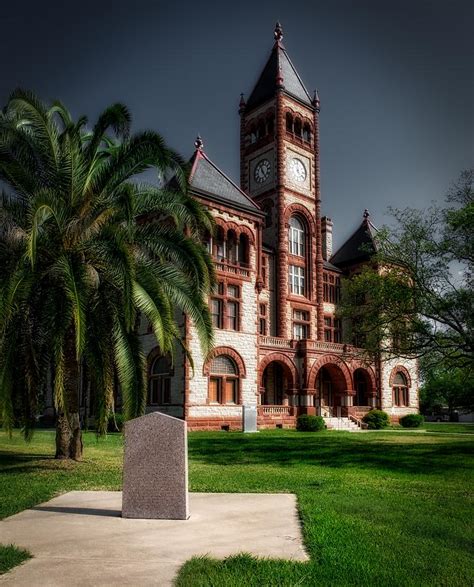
[{"x1": 246, "y1": 41, "x2": 313, "y2": 110}]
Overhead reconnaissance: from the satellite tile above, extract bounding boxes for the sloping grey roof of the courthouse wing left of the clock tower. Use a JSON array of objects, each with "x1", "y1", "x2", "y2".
[{"x1": 189, "y1": 149, "x2": 264, "y2": 216}]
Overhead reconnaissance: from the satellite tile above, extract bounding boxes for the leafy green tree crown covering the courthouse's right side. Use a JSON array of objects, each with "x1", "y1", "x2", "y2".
[{"x1": 340, "y1": 171, "x2": 474, "y2": 370}]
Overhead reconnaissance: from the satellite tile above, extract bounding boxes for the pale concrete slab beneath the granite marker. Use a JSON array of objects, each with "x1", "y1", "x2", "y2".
[{"x1": 0, "y1": 491, "x2": 308, "y2": 587}]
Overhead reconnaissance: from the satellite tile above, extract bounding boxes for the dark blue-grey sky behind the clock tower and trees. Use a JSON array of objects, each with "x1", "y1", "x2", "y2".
[{"x1": 0, "y1": 0, "x2": 474, "y2": 243}]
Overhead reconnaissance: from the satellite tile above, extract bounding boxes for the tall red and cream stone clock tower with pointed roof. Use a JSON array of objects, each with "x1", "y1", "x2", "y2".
[{"x1": 239, "y1": 23, "x2": 324, "y2": 340}]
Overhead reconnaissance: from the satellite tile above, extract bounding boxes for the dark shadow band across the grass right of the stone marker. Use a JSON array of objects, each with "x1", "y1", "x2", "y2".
[{"x1": 189, "y1": 432, "x2": 474, "y2": 475}]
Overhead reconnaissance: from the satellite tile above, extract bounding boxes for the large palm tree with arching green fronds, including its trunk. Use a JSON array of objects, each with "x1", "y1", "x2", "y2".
[{"x1": 0, "y1": 90, "x2": 214, "y2": 459}]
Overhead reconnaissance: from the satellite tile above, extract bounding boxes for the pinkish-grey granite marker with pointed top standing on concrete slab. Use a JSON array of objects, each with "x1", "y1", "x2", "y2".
[{"x1": 122, "y1": 412, "x2": 189, "y2": 520}]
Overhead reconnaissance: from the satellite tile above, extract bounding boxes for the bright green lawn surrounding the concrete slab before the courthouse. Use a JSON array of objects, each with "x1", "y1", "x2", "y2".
[{"x1": 0, "y1": 430, "x2": 474, "y2": 587}]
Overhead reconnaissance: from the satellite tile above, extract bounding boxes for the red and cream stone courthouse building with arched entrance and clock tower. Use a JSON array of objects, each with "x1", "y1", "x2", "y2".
[{"x1": 141, "y1": 25, "x2": 418, "y2": 430}]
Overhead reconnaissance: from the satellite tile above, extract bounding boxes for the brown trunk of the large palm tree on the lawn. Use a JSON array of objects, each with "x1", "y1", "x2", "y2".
[{"x1": 56, "y1": 328, "x2": 83, "y2": 461}]
